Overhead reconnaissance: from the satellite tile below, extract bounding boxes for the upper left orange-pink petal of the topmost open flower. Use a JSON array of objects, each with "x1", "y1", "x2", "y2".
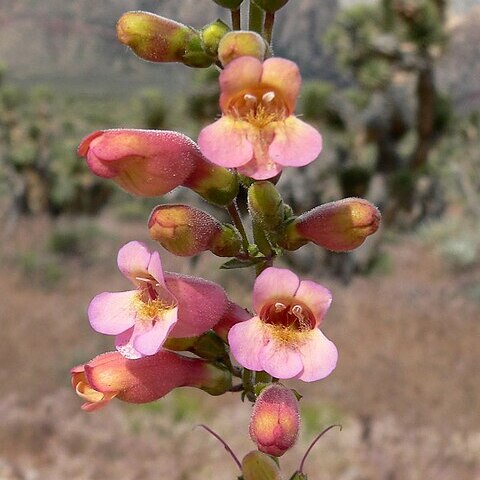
[{"x1": 219, "y1": 56, "x2": 263, "y2": 113}]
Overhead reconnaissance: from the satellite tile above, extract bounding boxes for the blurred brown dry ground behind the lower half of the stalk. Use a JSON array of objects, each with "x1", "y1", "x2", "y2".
[{"x1": 0, "y1": 217, "x2": 480, "y2": 480}]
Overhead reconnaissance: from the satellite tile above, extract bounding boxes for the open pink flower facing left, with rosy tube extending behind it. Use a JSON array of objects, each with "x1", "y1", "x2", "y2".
[{"x1": 88, "y1": 242, "x2": 229, "y2": 358}]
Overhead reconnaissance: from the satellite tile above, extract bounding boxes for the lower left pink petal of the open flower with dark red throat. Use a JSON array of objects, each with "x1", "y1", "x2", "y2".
[{"x1": 228, "y1": 317, "x2": 267, "y2": 371}]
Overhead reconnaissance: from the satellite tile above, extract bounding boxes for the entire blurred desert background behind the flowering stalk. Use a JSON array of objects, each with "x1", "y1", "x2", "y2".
[{"x1": 0, "y1": 0, "x2": 480, "y2": 480}]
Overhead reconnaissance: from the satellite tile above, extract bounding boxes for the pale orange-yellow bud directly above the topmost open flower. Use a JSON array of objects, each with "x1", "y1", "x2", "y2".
[{"x1": 218, "y1": 31, "x2": 267, "y2": 67}]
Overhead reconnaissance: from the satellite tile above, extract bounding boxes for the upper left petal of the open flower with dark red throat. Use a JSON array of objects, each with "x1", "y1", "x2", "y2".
[{"x1": 253, "y1": 267, "x2": 300, "y2": 313}]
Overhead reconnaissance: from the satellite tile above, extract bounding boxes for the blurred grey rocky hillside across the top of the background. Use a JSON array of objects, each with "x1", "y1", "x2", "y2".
[{"x1": 0, "y1": 0, "x2": 480, "y2": 108}]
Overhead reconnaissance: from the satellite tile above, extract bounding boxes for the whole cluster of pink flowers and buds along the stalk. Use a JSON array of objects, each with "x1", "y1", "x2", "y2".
[{"x1": 71, "y1": 0, "x2": 380, "y2": 480}]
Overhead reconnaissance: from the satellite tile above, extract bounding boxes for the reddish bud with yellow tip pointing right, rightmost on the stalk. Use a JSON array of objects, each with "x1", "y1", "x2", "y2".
[{"x1": 282, "y1": 198, "x2": 380, "y2": 252}]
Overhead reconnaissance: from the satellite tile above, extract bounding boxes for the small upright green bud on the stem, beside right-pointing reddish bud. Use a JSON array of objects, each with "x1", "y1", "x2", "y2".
[{"x1": 248, "y1": 181, "x2": 284, "y2": 235}]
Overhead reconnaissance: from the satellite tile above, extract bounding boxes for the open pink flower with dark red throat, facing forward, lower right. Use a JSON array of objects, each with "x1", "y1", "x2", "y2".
[{"x1": 228, "y1": 267, "x2": 338, "y2": 382}]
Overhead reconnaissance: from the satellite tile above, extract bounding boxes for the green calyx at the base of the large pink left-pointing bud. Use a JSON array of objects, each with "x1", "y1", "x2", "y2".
[{"x1": 183, "y1": 156, "x2": 238, "y2": 207}]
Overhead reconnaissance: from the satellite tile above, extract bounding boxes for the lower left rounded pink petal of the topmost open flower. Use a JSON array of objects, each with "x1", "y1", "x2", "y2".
[{"x1": 198, "y1": 115, "x2": 253, "y2": 168}]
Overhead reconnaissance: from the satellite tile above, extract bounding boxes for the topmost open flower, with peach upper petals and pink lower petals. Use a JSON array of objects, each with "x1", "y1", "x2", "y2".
[{"x1": 198, "y1": 56, "x2": 322, "y2": 180}]
